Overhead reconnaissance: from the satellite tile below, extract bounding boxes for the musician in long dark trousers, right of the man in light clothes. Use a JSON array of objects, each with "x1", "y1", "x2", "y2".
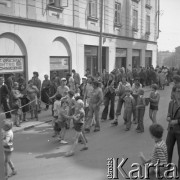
[{"x1": 101, "y1": 73, "x2": 115, "y2": 121}]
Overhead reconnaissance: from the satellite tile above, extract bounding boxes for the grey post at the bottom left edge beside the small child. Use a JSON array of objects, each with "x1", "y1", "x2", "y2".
[{"x1": 0, "y1": 111, "x2": 5, "y2": 180}]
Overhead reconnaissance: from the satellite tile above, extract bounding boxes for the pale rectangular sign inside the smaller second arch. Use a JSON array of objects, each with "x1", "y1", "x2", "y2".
[{"x1": 50, "y1": 57, "x2": 69, "y2": 71}]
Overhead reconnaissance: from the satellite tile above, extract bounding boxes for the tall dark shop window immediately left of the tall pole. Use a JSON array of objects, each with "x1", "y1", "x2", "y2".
[{"x1": 85, "y1": 46, "x2": 98, "y2": 76}]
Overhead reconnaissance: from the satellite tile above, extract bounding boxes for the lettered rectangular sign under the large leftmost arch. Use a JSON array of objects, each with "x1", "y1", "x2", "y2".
[{"x1": 0, "y1": 57, "x2": 24, "y2": 73}]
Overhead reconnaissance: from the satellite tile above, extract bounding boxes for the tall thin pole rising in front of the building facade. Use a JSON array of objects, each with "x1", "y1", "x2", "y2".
[{"x1": 98, "y1": 0, "x2": 104, "y2": 73}]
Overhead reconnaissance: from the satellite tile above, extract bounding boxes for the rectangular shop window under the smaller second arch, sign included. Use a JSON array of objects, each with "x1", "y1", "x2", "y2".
[{"x1": 50, "y1": 56, "x2": 70, "y2": 78}]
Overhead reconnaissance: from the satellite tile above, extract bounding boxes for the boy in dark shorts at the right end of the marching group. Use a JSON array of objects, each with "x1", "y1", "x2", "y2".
[{"x1": 149, "y1": 84, "x2": 160, "y2": 123}]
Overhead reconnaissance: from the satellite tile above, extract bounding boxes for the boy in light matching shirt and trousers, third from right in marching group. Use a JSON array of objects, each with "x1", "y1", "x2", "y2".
[{"x1": 123, "y1": 87, "x2": 135, "y2": 131}]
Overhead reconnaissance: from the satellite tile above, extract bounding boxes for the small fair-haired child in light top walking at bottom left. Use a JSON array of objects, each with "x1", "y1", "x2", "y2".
[{"x1": 3, "y1": 120, "x2": 17, "y2": 178}]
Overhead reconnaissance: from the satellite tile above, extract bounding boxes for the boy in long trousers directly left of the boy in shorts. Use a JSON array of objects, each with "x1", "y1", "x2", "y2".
[{"x1": 136, "y1": 89, "x2": 146, "y2": 133}]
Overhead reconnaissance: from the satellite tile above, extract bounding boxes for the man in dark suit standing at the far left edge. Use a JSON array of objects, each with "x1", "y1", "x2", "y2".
[{"x1": 0, "y1": 77, "x2": 11, "y2": 119}]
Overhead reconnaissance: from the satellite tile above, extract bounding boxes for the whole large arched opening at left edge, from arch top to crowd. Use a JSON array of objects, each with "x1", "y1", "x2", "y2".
[{"x1": 0, "y1": 32, "x2": 28, "y2": 80}]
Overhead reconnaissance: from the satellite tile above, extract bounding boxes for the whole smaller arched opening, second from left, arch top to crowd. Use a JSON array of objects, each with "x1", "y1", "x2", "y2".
[{"x1": 49, "y1": 37, "x2": 72, "y2": 78}]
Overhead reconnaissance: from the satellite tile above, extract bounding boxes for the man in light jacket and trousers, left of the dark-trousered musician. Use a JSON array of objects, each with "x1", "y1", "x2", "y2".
[{"x1": 85, "y1": 81, "x2": 103, "y2": 132}]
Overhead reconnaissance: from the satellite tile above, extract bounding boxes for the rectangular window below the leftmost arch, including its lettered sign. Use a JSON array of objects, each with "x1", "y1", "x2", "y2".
[{"x1": 0, "y1": 56, "x2": 26, "y2": 82}]
